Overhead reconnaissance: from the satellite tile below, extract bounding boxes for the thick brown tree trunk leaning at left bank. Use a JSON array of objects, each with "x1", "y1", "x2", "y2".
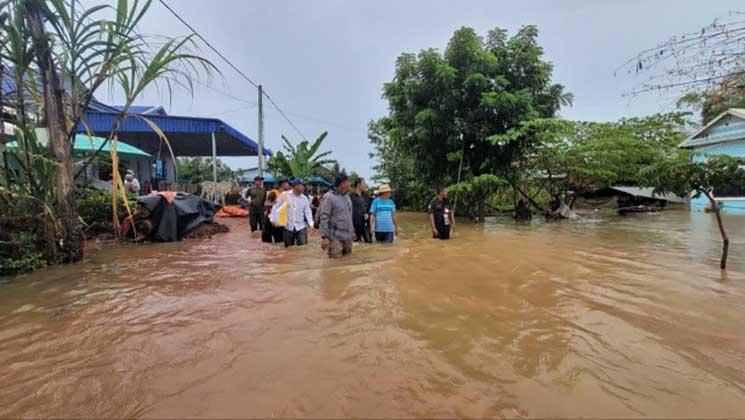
[{"x1": 24, "y1": 0, "x2": 84, "y2": 262}]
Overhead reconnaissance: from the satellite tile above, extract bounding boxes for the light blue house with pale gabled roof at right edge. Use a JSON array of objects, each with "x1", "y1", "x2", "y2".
[{"x1": 680, "y1": 108, "x2": 745, "y2": 214}]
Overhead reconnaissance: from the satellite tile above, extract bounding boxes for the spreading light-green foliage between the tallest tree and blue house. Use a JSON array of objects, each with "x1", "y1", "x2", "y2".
[{"x1": 512, "y1": 113, "x2": 689, "y2": 203}]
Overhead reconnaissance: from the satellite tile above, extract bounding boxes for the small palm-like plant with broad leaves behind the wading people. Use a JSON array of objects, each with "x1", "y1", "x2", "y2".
[{"x1": 269, "y1": 131, "x2": 336, "y2": 178}]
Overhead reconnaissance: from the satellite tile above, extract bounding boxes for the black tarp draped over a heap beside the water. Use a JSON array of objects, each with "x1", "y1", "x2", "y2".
[{"x1": 137, "y1": 193, "x2": 219, "y2": 242}]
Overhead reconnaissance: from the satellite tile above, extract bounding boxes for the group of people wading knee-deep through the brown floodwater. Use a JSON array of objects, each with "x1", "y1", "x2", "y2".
[{"x1": 245, "y1": 173, "x2": 455, "y2": 258}]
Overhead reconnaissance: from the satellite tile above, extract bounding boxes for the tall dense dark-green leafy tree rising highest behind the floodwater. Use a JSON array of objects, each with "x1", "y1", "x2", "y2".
[{"x1": 370, "y1": 26, "x2": 571, "y2": 217}]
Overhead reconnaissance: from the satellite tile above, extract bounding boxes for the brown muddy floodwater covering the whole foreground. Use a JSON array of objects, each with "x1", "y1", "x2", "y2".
[{"x1": 0, "y1": 213, "x2": 745, "y2": 418}]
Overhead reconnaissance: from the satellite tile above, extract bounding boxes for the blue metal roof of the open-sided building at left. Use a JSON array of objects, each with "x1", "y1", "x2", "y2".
[{"x1": 78, "y1": 110, "x2": 271, "y2": 156}]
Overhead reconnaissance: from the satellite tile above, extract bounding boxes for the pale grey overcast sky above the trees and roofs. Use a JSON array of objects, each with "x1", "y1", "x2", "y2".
[{"x1": 99, "y1": 0, "x2": 743, "y2": 176}]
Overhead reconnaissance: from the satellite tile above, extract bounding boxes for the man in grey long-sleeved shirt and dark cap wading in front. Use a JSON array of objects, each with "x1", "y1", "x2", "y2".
[{"x1": 318, "y1": 172, "x2": 354, "y2": 258}]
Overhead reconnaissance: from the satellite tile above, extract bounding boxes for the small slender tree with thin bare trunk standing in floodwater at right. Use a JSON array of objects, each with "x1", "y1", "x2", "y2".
[{"x1": 640, "y1": 151, "x2": 745, "y2": 270}]
